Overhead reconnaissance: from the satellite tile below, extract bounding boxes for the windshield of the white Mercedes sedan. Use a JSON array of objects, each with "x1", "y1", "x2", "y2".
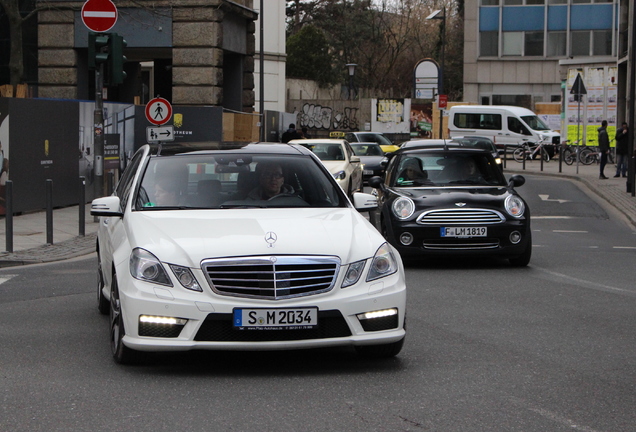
[{"x1": 135, "y1": 153, "x2": 346, "y2": 211}]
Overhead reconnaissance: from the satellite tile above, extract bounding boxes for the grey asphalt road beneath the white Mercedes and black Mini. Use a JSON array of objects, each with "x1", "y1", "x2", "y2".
[{"x1": 0, "y1": 177, "x2": 636, "y2": 432}]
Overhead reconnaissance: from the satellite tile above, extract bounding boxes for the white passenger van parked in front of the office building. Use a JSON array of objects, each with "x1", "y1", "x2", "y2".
[{"x1": 448, "y1": 105, "x2": 561, "y2": 151}]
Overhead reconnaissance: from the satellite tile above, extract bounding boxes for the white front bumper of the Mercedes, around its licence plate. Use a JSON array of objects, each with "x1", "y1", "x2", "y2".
[{"x1": 118, "y1": 266, "x2": 406, "y2": 351}]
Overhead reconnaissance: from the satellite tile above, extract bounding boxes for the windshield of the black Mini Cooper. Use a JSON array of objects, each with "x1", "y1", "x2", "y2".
[{"x1": 389, "y1": 152, "x2": 506, "y2": 187}]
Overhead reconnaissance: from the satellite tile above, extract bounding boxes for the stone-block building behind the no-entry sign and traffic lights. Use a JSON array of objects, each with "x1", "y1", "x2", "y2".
[{"x1": 38, "y1": 0, "x2": 258, "y2": 112}]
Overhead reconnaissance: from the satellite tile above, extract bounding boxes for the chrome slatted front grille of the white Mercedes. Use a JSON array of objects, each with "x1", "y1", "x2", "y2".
[{"x1": 201, "y1": 255, "x2": 340, "y2": 300}]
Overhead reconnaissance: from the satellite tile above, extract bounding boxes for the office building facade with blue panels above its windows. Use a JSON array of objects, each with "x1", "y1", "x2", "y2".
[{"x1": 464, "y1": 0, "x2": 619, "y2": 109}]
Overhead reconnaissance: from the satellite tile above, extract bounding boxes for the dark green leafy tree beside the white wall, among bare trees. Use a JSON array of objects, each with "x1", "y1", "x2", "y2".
[{"x1": 286, "y1": 25, "x2": 337, "y2": 86}]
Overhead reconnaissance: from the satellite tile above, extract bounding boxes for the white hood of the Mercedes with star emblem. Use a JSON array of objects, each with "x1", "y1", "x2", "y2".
[{"x1": 125, "y1": 208, "x2": 385, "y2": 268}]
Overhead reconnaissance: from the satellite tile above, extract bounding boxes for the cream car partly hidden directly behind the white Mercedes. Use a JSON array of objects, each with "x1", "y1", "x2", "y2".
[{"x1": 290, "y1": 139, "x2": 362, "y2": 197}]
